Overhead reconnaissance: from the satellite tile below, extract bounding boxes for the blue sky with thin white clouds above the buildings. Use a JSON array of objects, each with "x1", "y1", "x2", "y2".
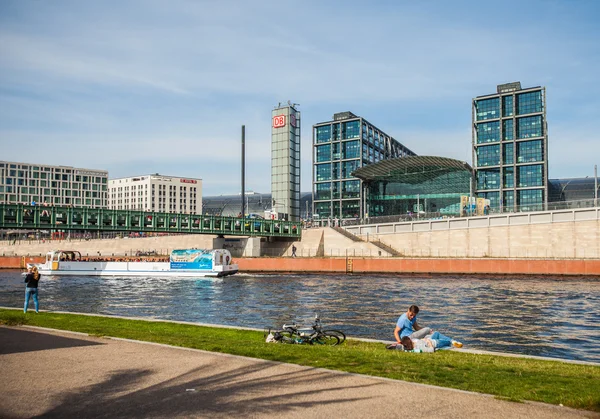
[{"x1": 0, "y1": 0, "x2": 600, "y2": 196}]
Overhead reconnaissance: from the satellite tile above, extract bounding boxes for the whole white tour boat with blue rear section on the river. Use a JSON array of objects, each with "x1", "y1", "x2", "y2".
[{"x1": 27, "y1": 249, "x2": 238, "y2": 278}]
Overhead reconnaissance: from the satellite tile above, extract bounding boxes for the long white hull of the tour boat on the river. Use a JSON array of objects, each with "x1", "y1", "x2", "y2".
[{"x1": 36, "y1": 261, "x2": 238, "y2": 278}]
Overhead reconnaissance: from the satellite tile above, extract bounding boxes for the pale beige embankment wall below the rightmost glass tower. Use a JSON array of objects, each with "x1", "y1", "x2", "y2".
[{"x1": 347, "y1": 208, "x2": 600, "y2": 259}]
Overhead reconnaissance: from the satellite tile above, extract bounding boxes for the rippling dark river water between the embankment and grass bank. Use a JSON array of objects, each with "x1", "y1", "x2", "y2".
[{"x1": 0, "y1": 270, "x2": 600, "y2": 362}]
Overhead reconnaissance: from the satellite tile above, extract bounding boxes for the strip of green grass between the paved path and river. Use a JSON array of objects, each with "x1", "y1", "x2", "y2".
[{"x1": 0, "y1": 309, "x2": 600, "y2": 411}]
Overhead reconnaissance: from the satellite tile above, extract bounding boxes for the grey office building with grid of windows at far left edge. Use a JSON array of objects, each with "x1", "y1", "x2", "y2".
[{"x1": 0, "y1": 161, "x2": 108, "y2": 208}]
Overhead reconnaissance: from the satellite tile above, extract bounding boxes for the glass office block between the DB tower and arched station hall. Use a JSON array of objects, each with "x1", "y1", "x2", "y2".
[{"x1": 312, "y1": 112, "x2": 416, "y2": 219}]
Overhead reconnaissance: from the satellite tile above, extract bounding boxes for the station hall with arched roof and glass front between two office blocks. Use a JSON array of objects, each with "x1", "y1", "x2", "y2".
[{"x1": 354, "y1": 156, "x2": 472, "y2": 217}]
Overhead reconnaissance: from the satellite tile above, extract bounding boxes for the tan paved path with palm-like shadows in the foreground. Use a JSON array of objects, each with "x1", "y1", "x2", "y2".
[{"x1": 0, "y1": 327, "x2": 600, "y2": 419}]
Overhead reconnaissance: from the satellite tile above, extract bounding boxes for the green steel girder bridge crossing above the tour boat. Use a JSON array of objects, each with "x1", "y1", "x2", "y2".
[{"x1": 0, "y1": 204, "x2": 302, "y2": 239}]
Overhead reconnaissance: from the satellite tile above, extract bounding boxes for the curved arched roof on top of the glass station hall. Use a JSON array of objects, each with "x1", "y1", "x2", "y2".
[{"x1": 352, "y1": 156, "x2": 473, "y2": 184}]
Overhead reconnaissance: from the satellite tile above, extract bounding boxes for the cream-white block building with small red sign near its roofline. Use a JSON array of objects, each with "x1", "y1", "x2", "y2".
[{"x1": 108, "y1": 173, "x2": 202, "y2": 214}]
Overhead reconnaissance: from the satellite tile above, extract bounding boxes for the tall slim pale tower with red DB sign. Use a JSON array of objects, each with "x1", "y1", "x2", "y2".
[{"x1": 271, "y1": 101, "x2": 300, "y2": 220}]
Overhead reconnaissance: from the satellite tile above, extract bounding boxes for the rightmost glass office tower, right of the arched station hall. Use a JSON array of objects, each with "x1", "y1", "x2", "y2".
[{"x1": 472, "y1": 82, "x2": 548, "y2": 212}]
